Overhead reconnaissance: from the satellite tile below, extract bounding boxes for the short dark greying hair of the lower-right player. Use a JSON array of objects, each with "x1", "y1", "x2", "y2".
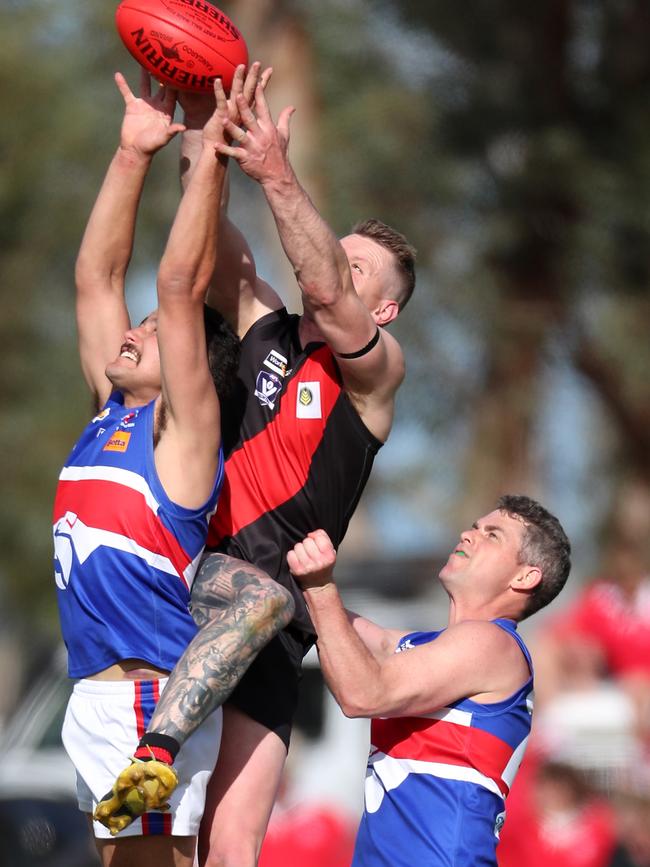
[{"x1": 497, "y1": 494, "x2": 571, "y2": 620}]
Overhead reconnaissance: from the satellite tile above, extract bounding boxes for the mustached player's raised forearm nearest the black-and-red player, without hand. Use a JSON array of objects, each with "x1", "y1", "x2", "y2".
[{"x1": 159, "y1": 146, "x2": 225, "y2": 297}]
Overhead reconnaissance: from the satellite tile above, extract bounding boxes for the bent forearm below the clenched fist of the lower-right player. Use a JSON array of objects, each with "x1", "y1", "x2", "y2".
[{"x1": 304, "y1": 583, "x2": 381, "y2": 717}]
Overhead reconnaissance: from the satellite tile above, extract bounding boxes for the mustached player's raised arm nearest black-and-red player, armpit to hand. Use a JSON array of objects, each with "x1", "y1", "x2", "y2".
[{"x1": 155, "y1": 80, "x2": 234, "y2": 508}]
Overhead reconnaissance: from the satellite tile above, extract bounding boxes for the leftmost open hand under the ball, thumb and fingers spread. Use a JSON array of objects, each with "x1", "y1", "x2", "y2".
[{"x1": 115, "y1": 69, "x2": 185, "y2": 156}]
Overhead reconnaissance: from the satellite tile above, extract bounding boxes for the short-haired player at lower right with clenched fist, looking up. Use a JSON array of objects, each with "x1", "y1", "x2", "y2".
[{"x1": 288, "y1": 496, "x2": 570, "y2": 867}]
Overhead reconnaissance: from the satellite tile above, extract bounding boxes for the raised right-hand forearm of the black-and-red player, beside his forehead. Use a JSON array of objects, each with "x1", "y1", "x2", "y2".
[{"x1": 262, "y1": 162, "x2": 349, "y2": 307}]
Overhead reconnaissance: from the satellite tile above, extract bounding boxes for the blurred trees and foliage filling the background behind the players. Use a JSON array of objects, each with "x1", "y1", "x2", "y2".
[{"x1": 0, "y1": 0, "x2": 650, "y2": 636}]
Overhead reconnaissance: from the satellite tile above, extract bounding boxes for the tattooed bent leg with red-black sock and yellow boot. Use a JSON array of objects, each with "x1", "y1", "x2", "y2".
[{"x1": 94, "y1": 554, "x2": 294, "y2": 835}]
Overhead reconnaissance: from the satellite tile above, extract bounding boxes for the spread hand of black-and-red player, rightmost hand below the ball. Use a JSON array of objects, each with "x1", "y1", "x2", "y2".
[{"x1": 215, "y1": 84, "x2": 295, "y2": 184}]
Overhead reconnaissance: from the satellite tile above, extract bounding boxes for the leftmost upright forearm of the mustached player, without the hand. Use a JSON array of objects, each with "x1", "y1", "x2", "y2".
[{"x1": 76, "y1": 148, "x2": 151, "y2": 291}]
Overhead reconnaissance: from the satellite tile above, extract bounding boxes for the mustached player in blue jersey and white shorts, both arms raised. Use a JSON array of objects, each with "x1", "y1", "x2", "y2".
[{"x1": 53, "y1": 67, "x2": 292, "y2": 867}]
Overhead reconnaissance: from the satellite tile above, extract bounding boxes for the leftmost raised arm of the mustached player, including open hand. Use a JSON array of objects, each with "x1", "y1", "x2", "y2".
[{"x1": 75, "y1": 70, "x2": 183, "y2": 404}]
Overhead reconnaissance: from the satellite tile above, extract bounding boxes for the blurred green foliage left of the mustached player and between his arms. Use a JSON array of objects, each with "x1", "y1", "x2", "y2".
[{"x1": 0, "y1": 0, "x2": 185, "y2": 640}]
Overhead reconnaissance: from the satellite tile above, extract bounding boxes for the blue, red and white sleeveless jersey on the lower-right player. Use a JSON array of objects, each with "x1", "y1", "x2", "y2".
[{"x1": 353, "y1": 619, "x2": 533, "y2": 867}]
